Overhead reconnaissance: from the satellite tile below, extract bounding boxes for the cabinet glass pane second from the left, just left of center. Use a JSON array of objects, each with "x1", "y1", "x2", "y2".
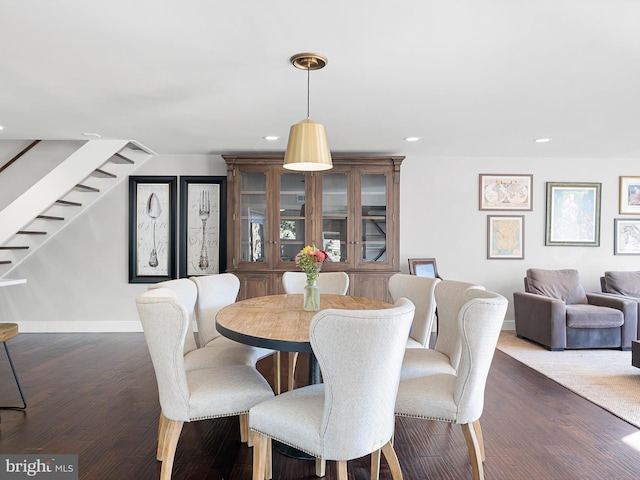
[{"x1": 278, "y1": 173, "x2": 306, "y2": 263}]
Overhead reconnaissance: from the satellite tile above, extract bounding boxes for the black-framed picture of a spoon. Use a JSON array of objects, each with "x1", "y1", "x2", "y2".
[{"x1": 129, "y1": 176, "x2": 178, "y2": 283}]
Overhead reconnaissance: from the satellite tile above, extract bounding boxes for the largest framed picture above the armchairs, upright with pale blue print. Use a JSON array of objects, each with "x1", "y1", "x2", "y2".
[{"x1": 545, "y1": 182, "x2": 601, "y2": 247}]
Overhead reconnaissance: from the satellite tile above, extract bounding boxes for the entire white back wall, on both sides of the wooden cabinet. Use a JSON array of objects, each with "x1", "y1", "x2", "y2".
[{"x1": 0, "y1": 155, "x2": 640, "y2": 332}]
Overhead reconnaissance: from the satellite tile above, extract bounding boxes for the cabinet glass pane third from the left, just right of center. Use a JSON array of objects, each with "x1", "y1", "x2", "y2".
[{"x1": 322, "y1": 173, "x2": 349, "y2": 262}]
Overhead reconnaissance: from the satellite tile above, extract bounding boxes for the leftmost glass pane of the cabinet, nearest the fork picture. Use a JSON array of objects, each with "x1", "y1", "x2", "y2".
[{"x1": 240, "y1": 172, "x2": 267, "y2": 262}]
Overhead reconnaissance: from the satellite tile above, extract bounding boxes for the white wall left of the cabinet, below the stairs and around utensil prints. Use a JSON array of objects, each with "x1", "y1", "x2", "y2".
[{"x1": 0, "y1": 155, "x2": 227, "y2": 332}]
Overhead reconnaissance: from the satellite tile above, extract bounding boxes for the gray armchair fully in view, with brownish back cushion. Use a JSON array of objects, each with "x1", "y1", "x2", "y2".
[{"x1": 513, "y1": 268, "x2": 638, "y2": 350}]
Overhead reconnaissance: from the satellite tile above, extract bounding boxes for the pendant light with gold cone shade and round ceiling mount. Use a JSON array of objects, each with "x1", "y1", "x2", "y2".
[{"x1": 284, "y1": 53, "x2": 333, "y2": 172}]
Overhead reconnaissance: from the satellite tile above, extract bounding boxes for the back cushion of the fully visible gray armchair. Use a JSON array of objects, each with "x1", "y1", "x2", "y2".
[{"x1": 527, "y1": 268, "x2": 587, "y2": 305}]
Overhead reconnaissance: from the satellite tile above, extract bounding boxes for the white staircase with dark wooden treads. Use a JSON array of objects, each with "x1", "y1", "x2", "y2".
[{"x1": 0, "y1": 140, "x2": 155, "y2": 279}]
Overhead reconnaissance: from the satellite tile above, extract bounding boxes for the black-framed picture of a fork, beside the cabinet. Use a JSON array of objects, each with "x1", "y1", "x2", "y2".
[{"x1": 178, "y1": 176, "x2": 227, "y2": 278}]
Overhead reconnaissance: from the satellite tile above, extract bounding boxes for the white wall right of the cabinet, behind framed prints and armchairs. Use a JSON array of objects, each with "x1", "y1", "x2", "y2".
[{"x1": 400, "y1": 158, "x2": 640, "y2": 328}]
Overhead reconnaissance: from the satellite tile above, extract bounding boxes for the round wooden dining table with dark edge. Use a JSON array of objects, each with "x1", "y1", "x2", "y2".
[{"x1": 216, "y1": 294, "x2": 393, "y2": 384}]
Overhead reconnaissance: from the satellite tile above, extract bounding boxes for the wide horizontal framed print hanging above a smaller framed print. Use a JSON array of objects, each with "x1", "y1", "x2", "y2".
[{"x1": 480, "y1": 173, "x2": 533, "y2": 210}]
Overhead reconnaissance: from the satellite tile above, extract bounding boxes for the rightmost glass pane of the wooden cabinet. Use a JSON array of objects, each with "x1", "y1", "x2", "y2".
[{"x1": 360, "y1": 174, "x2": 387, "y2": 262}]
